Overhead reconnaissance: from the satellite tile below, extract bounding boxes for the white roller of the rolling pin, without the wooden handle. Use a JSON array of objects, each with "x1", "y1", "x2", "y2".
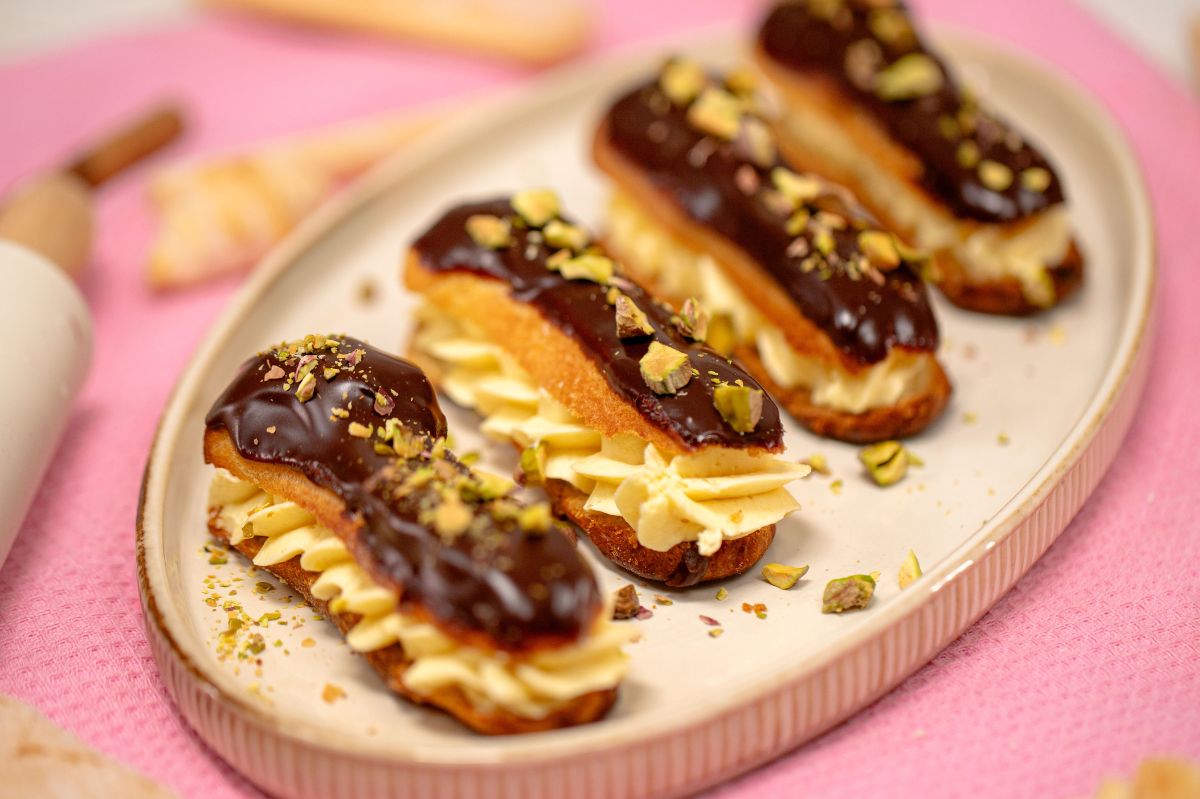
[{"x1": 0, "y1": 240, "x2": 91, "y2": 564}]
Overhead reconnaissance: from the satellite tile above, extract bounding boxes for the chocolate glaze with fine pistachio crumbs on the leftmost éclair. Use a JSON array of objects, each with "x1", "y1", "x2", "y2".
[{"x1": 205, "y1": 336, "x2": 602, "y2": 650}]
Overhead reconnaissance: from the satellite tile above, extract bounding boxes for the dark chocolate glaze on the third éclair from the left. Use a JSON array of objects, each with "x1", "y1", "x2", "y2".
[{"x1": 601, "y1": 76, "x2": 937, "y2": 365}]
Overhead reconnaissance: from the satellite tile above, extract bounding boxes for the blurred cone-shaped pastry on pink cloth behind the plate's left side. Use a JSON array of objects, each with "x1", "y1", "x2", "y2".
[{"x1": 146, "y1": 113, "x2": 442, "y2": 289}]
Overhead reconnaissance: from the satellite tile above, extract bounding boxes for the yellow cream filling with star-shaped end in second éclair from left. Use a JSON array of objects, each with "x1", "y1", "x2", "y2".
[{"x1": 415, "y1": 307, "x2": 809, "y2": 555}]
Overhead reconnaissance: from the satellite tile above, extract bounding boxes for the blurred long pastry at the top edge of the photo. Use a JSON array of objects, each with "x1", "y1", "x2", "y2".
[{"x1": 202, "y1": 0, "x2": 592, "y2": 64}]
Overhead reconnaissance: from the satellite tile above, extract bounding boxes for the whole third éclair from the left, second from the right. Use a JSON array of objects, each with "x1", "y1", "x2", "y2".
[{"x1": 594, "y1": 60, "x2": 950, "y2": 441}]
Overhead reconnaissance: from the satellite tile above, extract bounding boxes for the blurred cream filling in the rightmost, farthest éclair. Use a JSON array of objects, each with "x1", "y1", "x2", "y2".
[{"x1": 784, "y1": 107, "x2": 1070, "y2": 307}]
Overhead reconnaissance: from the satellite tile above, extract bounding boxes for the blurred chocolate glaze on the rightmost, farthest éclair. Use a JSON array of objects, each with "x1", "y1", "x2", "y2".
[{"x1": 758, "y1": 0, "x2": 1063, "y2": 223}]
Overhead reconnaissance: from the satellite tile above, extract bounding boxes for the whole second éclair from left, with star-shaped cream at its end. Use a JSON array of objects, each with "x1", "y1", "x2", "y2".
[{"x1": 404, "y1": 190, "x2": 808, "y2": 585}]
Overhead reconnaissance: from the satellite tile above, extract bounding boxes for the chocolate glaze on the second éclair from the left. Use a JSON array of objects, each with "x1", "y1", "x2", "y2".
[{"x1": 413, "y1": 198, "x2": 784, "y2": 451}]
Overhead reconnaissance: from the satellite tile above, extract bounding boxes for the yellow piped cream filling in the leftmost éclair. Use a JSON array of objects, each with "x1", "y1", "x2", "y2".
[{"x1": 209, "y1": 469, "x2": 636, "y2": 719}]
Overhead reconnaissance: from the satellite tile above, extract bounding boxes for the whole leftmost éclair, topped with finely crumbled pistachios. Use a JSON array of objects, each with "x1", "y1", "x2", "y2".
[{"x1": 204, "y1": 336, "x2": 630, "y2": 733}]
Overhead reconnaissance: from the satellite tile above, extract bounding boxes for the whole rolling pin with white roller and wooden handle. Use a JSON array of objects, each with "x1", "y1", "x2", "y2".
[{"x1": 0, "y1": 108, "x2": 182, "y2": 566}]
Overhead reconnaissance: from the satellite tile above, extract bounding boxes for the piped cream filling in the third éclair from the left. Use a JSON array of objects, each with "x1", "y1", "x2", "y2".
[{"x1": 606, "y1": 194, "x2": 934, "y2": 414}]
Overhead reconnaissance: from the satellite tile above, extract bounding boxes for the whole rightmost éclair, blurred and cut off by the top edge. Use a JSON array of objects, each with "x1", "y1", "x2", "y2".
[{"x1": 757, "y1": 0, "x2": 1084, "y2": 314}]
